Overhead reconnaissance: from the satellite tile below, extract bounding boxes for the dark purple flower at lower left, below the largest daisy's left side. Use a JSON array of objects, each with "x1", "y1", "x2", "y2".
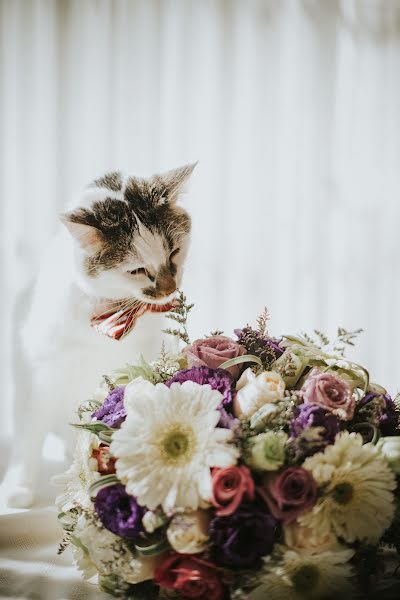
[{"x1": 95, "y1": 483, "x2": 145, "y2": 538}]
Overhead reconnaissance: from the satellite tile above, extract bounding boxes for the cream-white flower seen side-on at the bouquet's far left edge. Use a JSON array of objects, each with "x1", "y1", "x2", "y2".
[{"x1": 52, "y1": 429, "x2": 100, "y2": 512}]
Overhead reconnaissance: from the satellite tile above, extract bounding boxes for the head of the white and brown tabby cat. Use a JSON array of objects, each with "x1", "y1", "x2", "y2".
[{"x1": 62, "y1": 164, "x2": 195, "y2": 304}]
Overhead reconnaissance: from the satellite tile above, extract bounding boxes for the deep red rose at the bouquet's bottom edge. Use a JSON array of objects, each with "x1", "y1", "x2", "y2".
[{"x1": 154, "y1": 554, "x2": 226, "y2": 600}]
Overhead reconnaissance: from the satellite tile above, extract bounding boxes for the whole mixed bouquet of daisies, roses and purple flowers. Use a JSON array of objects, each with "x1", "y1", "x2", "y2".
[{"x1": 57, "y1": 295, "x2": 400, "y2": 600}]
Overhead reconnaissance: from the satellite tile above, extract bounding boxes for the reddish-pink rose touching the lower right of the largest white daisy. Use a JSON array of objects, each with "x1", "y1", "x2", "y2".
[{"x1": 211, "y1": 466, "x2": 254, "y2": 517}]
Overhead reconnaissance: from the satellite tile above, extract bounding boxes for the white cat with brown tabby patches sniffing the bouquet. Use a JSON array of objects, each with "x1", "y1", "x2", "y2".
[{"x1": 6, "y1": 164, "x2": 195, "y2": 508}]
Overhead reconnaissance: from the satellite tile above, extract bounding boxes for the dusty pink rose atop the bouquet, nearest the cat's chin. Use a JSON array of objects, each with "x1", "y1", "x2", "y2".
[{"x1": 184, "y1": 335, "x2": 246, "y2": 378}]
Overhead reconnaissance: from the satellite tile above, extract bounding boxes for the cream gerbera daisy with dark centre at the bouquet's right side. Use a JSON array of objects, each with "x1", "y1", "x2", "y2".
[{"x1": 298, "y1": 431, "x2": 396, "y2": 544}]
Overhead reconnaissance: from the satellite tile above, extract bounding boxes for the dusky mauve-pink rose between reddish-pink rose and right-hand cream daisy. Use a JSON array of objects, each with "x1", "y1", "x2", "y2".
[{"x1": 257, "y1": 467, "x2": 317, "y2": 524}]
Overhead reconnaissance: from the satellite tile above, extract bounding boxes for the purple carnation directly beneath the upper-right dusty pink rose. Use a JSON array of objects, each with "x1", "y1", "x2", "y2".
[{"x1": 290, "y1": 402, "x2": 340, "y2": 445}]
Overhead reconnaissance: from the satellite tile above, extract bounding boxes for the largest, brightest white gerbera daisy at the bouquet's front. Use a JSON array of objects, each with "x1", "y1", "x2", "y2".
[{"x1": 111, "y1": 380, "x2": 238, "y2": 513}]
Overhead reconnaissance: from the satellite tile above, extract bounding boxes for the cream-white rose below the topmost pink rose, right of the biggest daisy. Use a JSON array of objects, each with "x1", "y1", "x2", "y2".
[{"x1": 233, "y1": 368, "x2": 285, "y2": 417}]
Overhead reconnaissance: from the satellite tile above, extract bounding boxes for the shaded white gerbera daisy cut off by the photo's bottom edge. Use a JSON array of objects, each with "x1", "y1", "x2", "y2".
[{"x1": 249, "y1": 547, "x2": 354, "y2": 600}]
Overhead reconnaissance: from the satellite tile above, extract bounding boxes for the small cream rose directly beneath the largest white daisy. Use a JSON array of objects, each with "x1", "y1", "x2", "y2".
[{"x1": 167, "y1": 510, "x2": 210, "y2": 554}]
